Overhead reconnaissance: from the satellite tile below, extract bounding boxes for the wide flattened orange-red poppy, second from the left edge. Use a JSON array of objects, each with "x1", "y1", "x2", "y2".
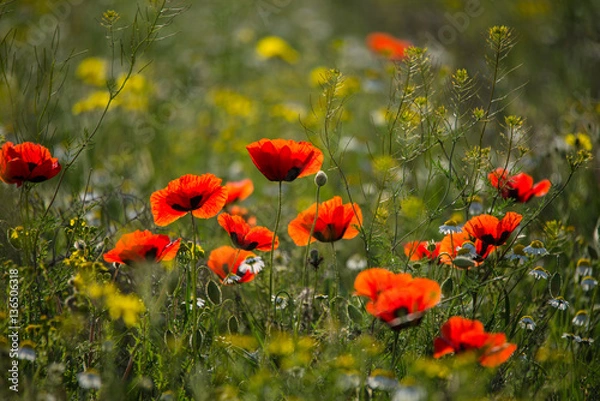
[{"x1": 104, "y1": 230, "x2": 181, "y2": 265}]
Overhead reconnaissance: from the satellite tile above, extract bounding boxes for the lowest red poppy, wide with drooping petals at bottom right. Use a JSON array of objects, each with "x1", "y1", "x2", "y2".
[{"x1": 433, "y1": 316, "x2": 517, "y2": 367}]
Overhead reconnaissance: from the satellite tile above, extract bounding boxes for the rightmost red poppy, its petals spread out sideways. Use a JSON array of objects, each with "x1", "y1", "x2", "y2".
[{"x1": 488, "y1": 167, "x2": 552, "y2": 203}]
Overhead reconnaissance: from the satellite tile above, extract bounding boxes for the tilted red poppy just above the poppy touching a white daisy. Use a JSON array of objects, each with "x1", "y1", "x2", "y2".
[{"x1": 218, "y1": 213, "x2": 279, "y2": 251}]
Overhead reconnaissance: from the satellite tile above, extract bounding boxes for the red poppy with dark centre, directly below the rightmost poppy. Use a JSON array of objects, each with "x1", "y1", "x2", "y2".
[{"x1": 464, "y1": 212, "x2": 523, "y2": 246}]
